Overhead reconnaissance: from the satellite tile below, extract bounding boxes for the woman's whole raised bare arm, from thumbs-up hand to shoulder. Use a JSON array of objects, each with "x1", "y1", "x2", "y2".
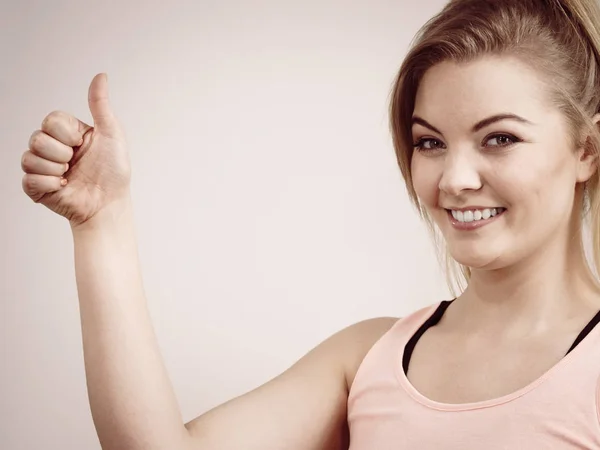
[{"x1": 22, "y1": 75, "x2": 394, "y2": 450}]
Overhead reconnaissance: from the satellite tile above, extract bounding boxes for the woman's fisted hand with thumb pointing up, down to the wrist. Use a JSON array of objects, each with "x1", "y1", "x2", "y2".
[{"x1": 21, "y1": 74, "x2": 131, "y2": 226}]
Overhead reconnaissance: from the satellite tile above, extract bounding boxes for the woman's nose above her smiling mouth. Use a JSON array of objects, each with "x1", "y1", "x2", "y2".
[{"x1": 439, "y1": 151, "x2": 482, "y2": 196}]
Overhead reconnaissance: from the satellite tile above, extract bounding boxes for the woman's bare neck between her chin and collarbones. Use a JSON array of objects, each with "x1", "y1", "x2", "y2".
[{"x1": 457, "y1": 218, "x2": 600, "y2": 333}]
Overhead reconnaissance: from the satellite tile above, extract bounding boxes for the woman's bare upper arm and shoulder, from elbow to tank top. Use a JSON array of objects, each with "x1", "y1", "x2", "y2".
[{"x1": 186, "y1": 317, "x2": 398, "y2": 450}]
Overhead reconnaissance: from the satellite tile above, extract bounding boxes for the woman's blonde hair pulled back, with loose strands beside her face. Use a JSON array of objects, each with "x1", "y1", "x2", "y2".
[{"x1": 390, "y1": 0, "x2": 600, "y2": 294}]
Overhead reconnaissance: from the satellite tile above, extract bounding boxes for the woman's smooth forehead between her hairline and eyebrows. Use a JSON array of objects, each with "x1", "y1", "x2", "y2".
[{"x1": 414, "y1": 56, "x2": 557, "y2": 127}]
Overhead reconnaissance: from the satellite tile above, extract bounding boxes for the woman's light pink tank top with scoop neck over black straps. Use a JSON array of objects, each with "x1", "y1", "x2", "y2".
[{"x1": 348, "y1": 303, "x2": 600, "y2": 450}]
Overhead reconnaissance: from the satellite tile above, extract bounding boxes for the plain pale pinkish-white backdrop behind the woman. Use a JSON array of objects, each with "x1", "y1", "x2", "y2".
[{"x1": 0, "y1": 0, "x2": 449, "y2": 450}]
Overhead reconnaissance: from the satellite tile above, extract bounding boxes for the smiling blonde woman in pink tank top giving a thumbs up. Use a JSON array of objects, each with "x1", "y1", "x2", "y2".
[{"x1": 22, "y1": 0, "x2": 600, "y2": 450}]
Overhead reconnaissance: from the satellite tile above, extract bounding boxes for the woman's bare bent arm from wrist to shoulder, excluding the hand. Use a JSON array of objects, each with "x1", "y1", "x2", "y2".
[{"x1": 73, "y1": 195, "x2": 393, "y2": 450}]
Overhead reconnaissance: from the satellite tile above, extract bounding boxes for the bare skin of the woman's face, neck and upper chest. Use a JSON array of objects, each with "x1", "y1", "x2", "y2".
[{"x1": 409, "y1": 56, "x2": 600, "y2": 403}]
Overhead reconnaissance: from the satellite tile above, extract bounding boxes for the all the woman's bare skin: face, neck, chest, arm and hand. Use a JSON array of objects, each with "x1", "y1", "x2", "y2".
[{"x1": 21, "y1": 54, "x2": 600, "y2": 444}]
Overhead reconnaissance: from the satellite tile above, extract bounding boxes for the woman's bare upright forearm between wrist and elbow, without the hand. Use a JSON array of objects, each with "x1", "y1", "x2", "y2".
[{"x1": 72, "y1": 197, "x2": 189, "y2": 450}]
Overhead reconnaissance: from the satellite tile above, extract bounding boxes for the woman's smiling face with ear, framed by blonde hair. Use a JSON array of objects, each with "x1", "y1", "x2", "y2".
[{"x1": 411, "y1": 57, "x2": 593, "y2": 269}]
